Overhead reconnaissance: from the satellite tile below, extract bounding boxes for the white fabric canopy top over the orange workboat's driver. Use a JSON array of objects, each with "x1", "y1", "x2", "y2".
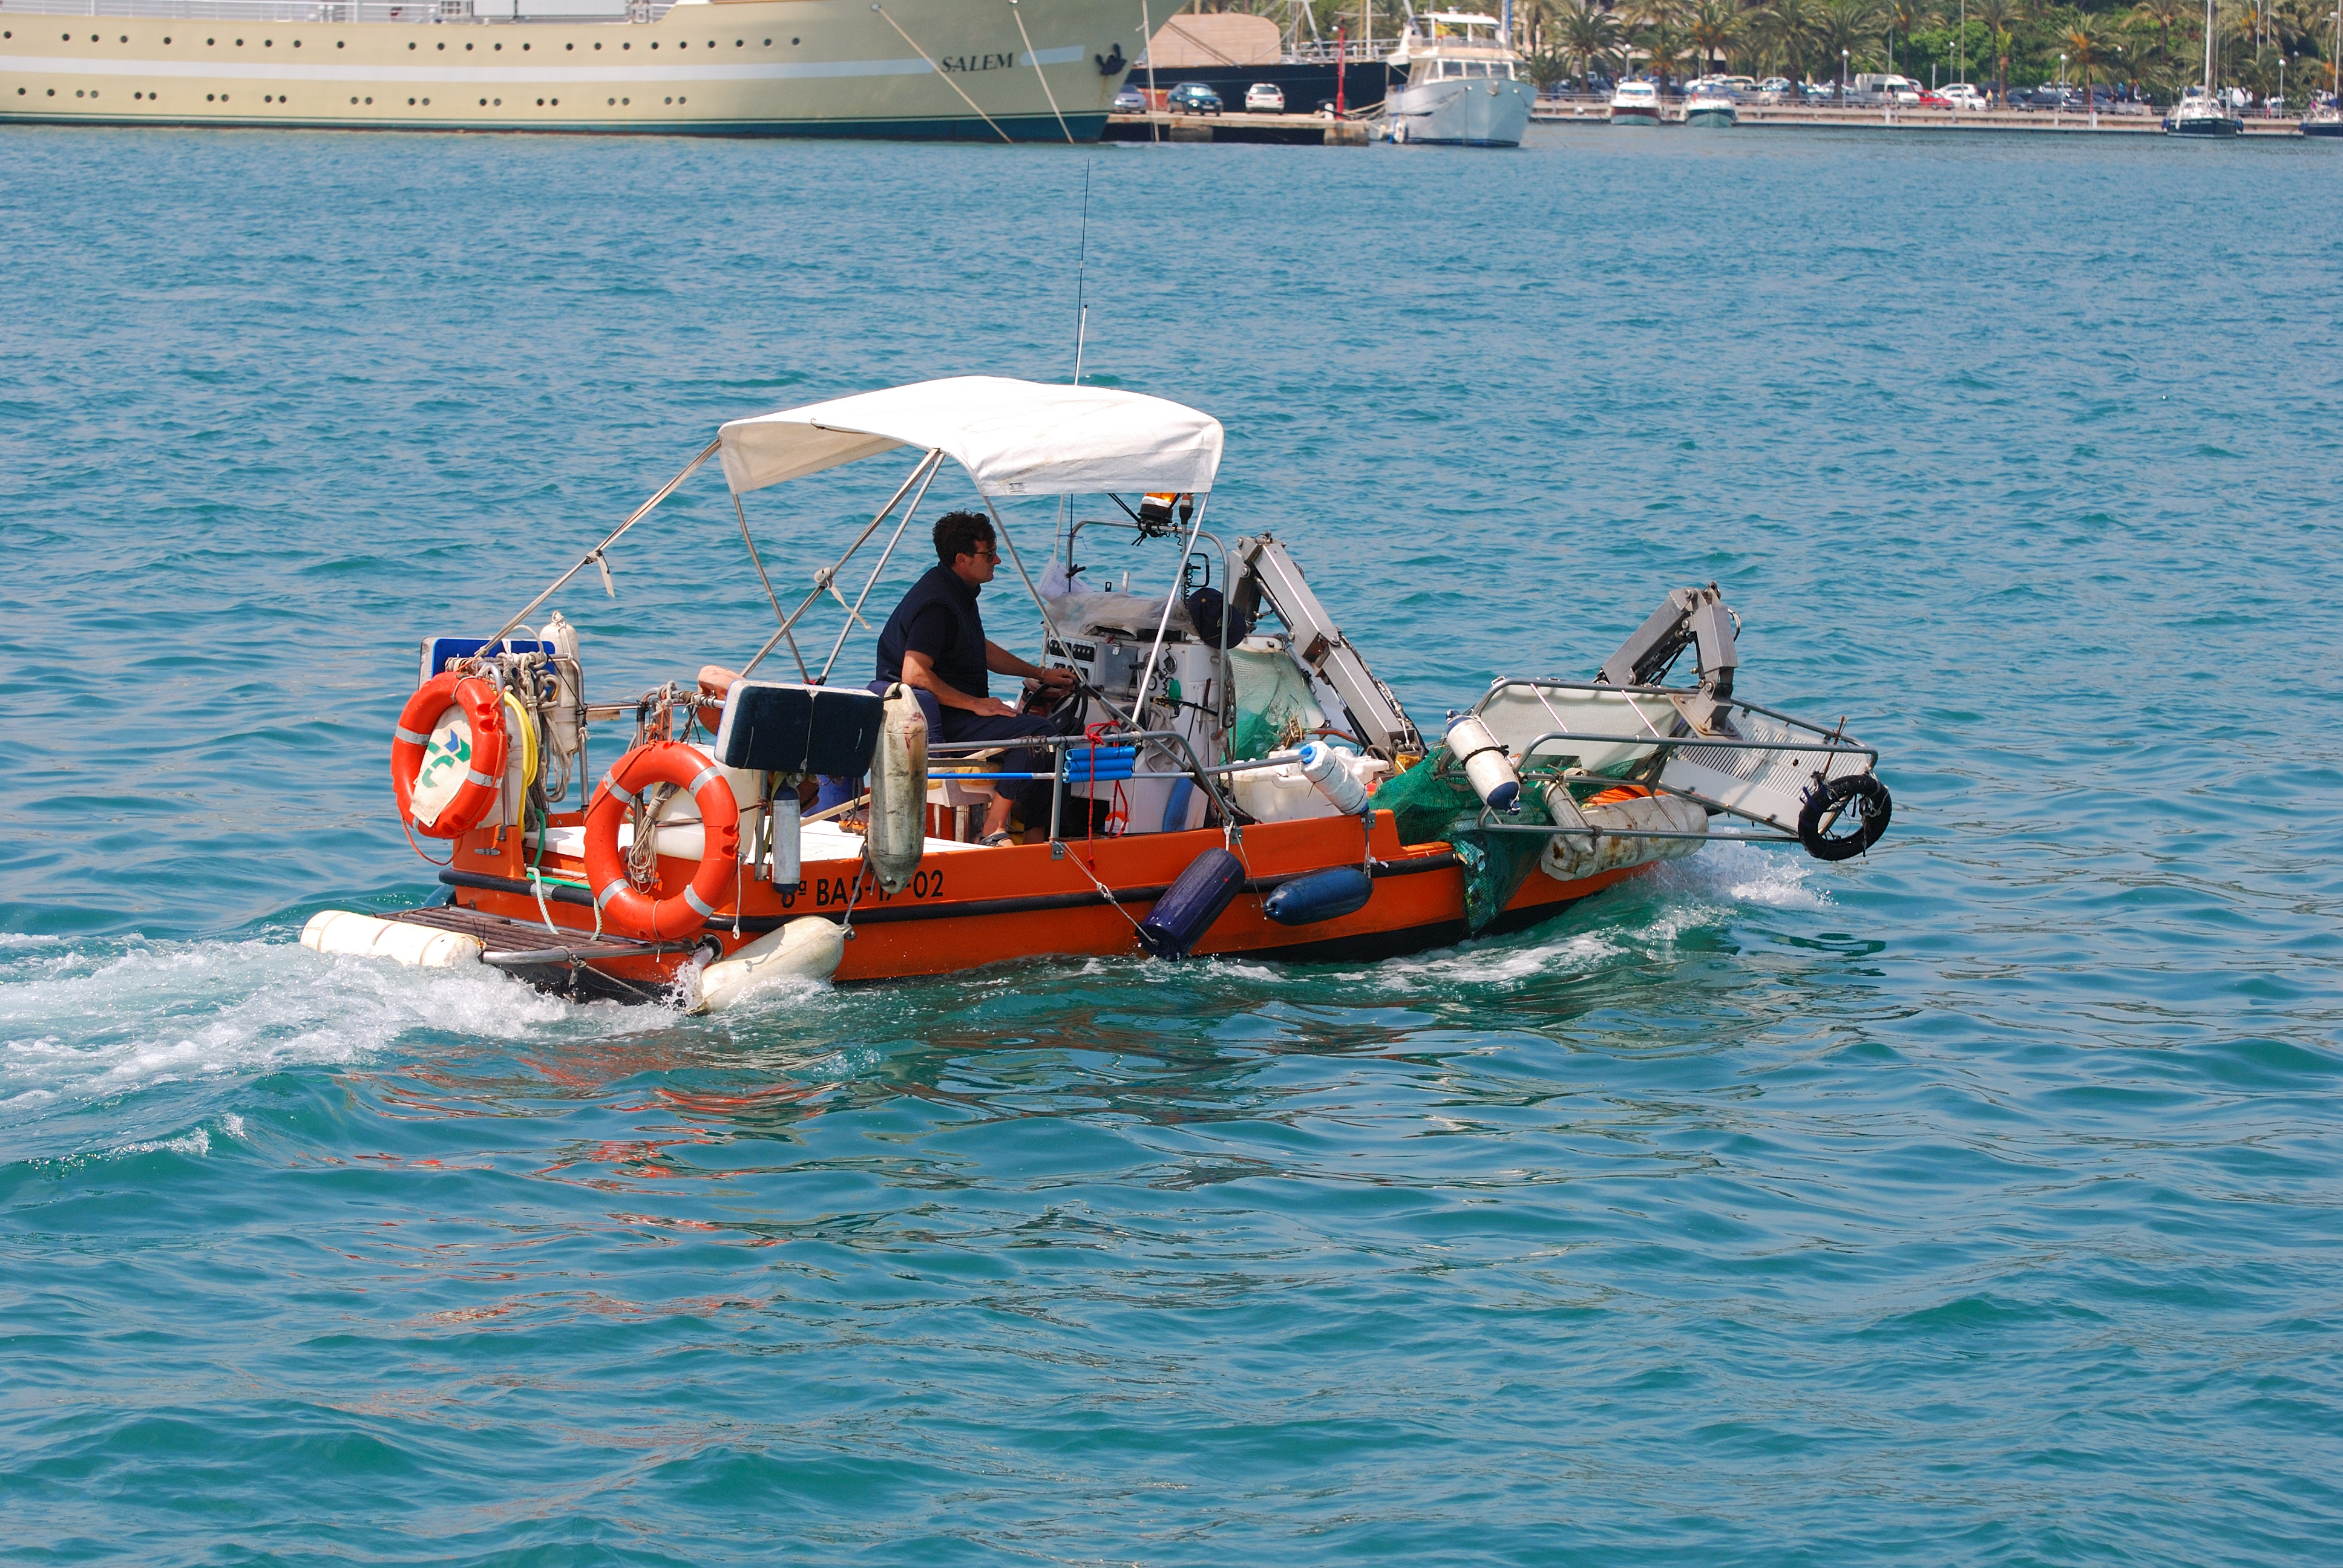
[{"x1": 717, "y1": 375, "x2": 1221, "y2": 497}]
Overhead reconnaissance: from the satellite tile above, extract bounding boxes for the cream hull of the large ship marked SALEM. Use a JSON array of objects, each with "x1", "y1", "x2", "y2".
[{"x1": 0, "y1": 0, "x2": 1139, "y2": 140}]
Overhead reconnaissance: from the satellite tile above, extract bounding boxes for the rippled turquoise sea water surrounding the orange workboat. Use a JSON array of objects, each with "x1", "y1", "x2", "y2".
[{"x1": 0, "y1": 131, "x2": 2343, "y2": 1563}]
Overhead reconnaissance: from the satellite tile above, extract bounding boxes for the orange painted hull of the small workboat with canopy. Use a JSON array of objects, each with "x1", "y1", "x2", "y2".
[{"x1": 441, "y1": 811, "x2": 1645, "y2": 991}]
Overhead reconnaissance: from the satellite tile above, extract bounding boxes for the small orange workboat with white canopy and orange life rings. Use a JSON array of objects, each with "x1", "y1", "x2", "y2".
[{"x1": 302, "y1": 377, "x2": 1891, "y2": 1008}]
